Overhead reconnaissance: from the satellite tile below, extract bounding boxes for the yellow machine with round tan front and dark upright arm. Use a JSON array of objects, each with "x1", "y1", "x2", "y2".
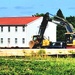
[{"x1": 29, "y1": 12, "x2": 52, "y2": 48}]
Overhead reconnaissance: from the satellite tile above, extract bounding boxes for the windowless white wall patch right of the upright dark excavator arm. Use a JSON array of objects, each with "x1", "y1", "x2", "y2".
[{"x1": 44, "y1": 22, "x2": 56, "y2": 42}]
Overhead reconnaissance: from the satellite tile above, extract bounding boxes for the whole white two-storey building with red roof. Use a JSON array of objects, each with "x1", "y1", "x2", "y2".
[{"x1": 0, "y1": 17, "x2": 56, "y2": 47}]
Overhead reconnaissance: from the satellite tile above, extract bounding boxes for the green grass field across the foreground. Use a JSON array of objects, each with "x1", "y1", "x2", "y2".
[{"x1": 0, "y1": 57, "x2": 75, "y2": 75}]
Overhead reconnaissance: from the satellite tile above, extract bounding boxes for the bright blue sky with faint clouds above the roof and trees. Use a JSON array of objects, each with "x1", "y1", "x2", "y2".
[{"x1": 0, "y1": 0, "x2": 75, "y2": 17}]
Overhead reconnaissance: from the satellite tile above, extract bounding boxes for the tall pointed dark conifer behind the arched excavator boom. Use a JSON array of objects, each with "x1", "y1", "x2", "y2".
[{"x1": 56, "y1": 9, "x2": 66, "y2": 41}]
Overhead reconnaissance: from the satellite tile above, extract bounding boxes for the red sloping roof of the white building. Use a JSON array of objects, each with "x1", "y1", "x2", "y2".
[{"x1": 0, "y1": 16, "x2": 39, "y2": 26}]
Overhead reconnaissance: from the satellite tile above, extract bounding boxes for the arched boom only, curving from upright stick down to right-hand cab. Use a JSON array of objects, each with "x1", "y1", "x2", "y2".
[{"x1": 50, "y1": 14, "x2": 75, "y2": 33}]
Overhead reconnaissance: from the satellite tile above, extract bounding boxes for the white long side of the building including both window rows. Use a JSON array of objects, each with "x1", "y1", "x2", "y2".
[{"x1": 0, "y1": 26, "x2": 26, "y2": 47}]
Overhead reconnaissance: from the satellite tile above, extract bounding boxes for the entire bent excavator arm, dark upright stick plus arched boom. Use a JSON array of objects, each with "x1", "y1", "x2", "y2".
[{"x1": 38, "y1": 12, "x2": 75, "y2": 38}]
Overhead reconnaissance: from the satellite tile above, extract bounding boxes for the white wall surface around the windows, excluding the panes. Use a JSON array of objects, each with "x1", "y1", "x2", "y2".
[{"x1": 0, "y1": 26, "x2": 26, "y2": 47}]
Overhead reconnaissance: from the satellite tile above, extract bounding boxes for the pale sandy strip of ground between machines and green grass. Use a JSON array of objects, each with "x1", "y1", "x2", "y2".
[{"x1": 0, "y1": 49, "x2": 75, "y2": 56}]
